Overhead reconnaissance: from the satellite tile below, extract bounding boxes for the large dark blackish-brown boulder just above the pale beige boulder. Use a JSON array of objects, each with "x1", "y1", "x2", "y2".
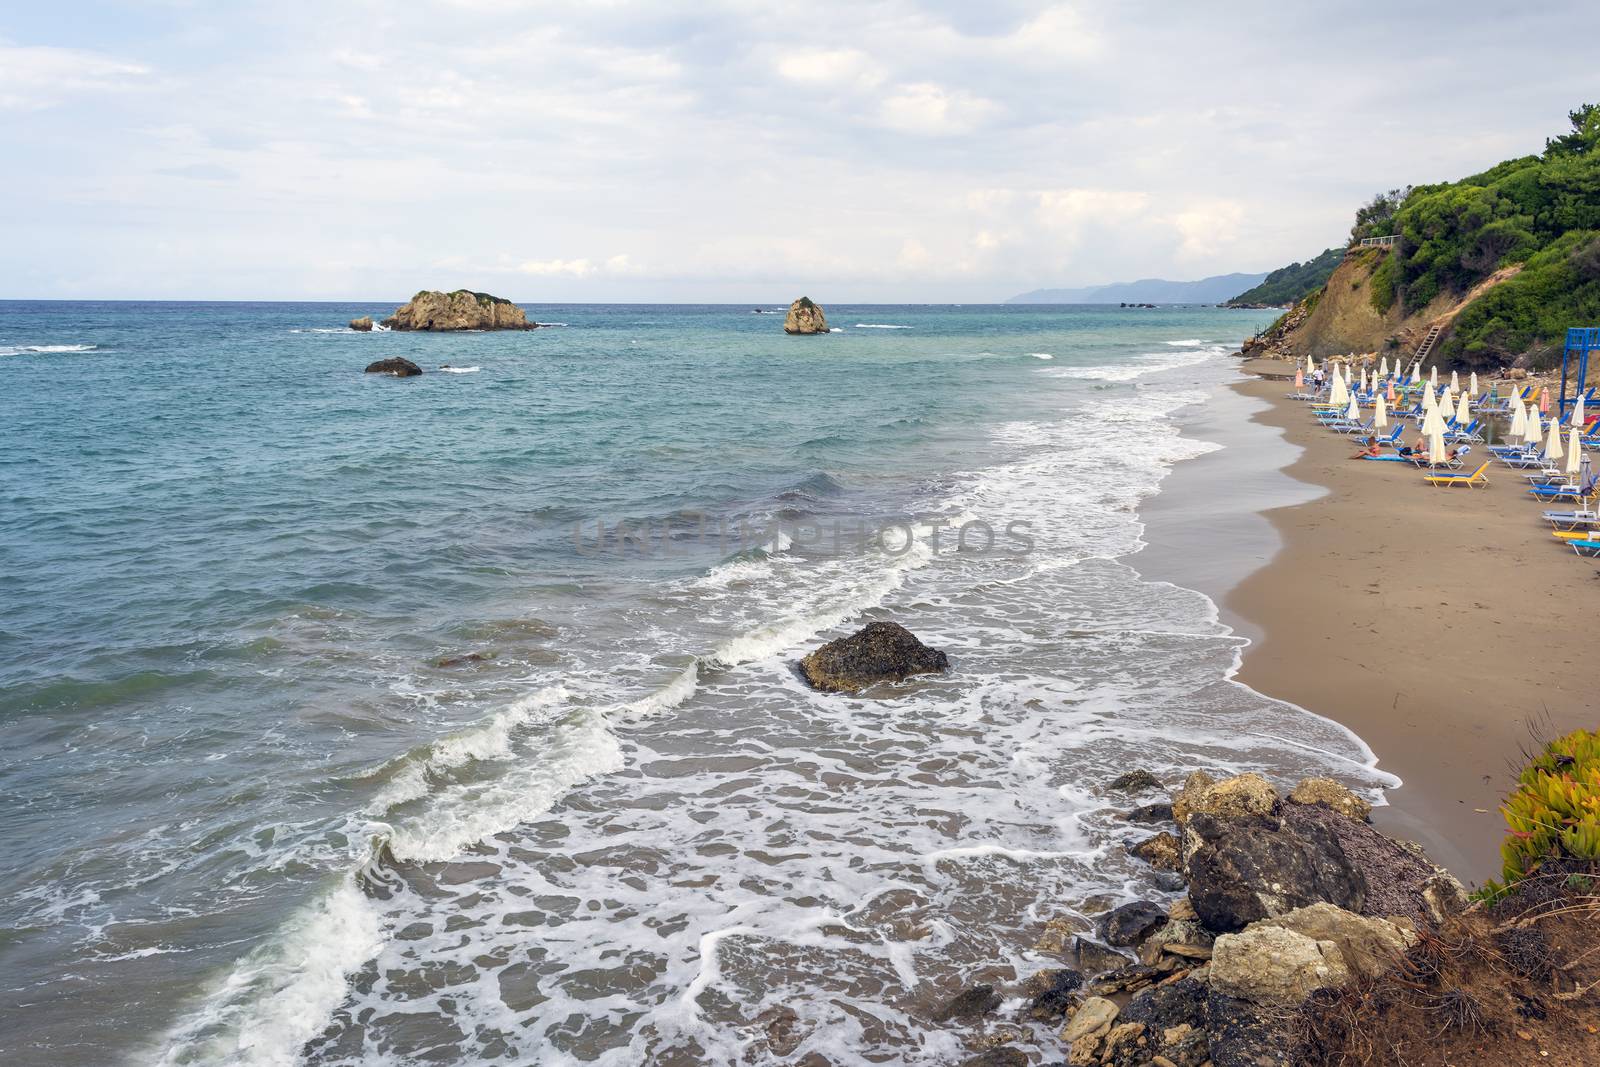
[{"x1": 1184, "y1": 813, "x2": 1366, "y2": 931}]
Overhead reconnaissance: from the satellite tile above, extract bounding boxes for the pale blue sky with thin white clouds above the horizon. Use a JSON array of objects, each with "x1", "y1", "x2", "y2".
[{"x1": 0, "y1": 0, "x2": 1600, "y2": 304}]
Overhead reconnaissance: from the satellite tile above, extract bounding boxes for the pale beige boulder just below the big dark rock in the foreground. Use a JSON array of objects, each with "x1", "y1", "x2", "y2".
[{"x1": 1210, "y1": 923, "x2": 1350, "y2": 1008}]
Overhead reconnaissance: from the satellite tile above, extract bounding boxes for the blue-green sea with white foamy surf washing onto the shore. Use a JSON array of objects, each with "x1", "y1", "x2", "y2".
[{"x1": 0, "y1": 301, "x2": 1382, "y2": 1067}]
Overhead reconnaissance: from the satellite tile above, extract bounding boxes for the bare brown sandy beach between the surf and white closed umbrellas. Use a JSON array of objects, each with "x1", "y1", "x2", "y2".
[{"x1": 1224, "y1": 360, "x2": 1600, "y2": 883}]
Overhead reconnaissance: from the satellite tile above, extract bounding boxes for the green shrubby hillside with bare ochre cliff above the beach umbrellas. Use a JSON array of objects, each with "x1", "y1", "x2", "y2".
[{"x1": 1240, "y1": 104, "x2": 1600, "y2": 368}]
